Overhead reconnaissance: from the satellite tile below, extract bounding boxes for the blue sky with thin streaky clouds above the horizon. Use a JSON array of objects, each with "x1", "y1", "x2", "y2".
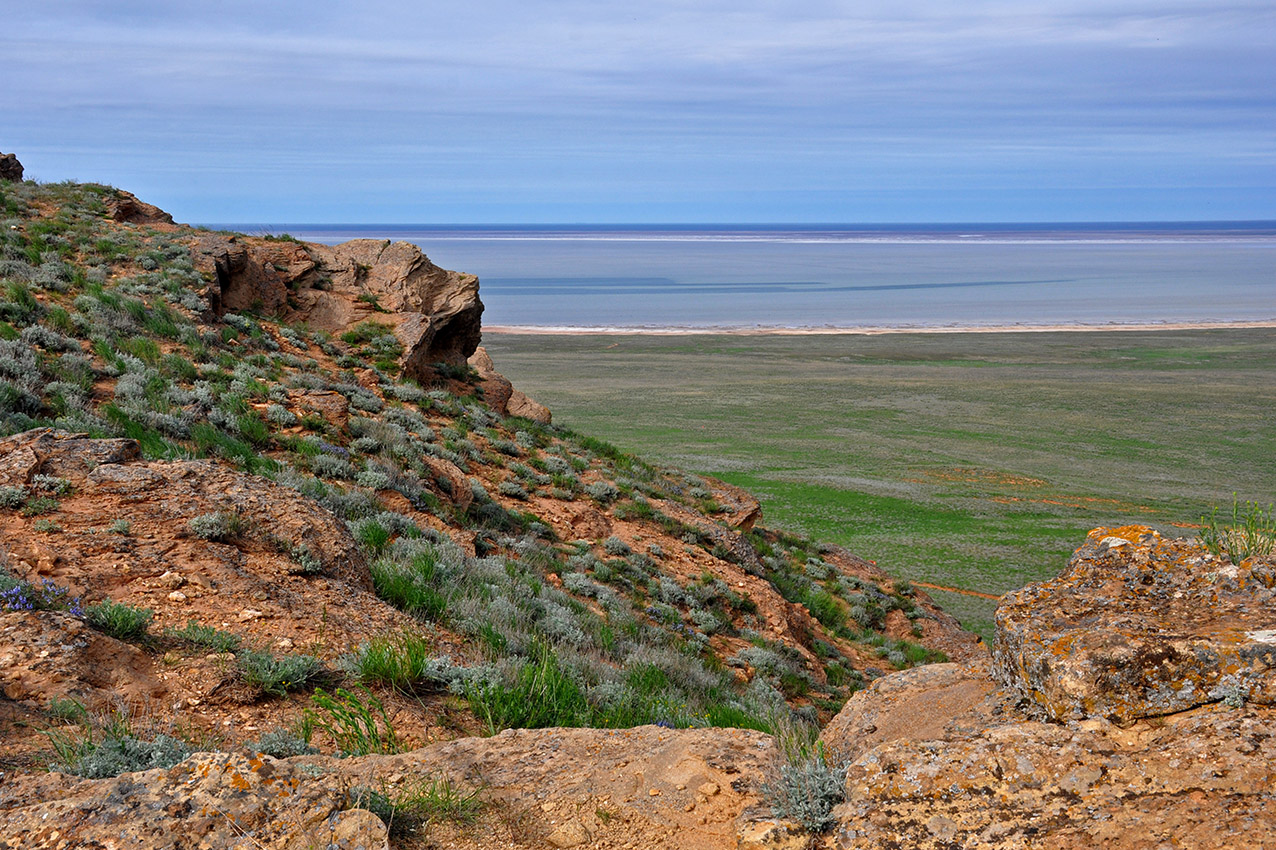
[{"x1": 0, "y1": 0, "x2": 1276, "y2": 223}]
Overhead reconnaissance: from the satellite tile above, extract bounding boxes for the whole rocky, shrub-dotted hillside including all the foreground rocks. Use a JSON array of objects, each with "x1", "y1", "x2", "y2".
[{"x1": 0, "y1": 162, "x2": 1276, "y2": 849}]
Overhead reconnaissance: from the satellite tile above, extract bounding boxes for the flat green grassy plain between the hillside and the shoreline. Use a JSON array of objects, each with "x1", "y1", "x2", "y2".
[{"x1": 484, "y1": 329, "x2": 1276, "y2": 636}]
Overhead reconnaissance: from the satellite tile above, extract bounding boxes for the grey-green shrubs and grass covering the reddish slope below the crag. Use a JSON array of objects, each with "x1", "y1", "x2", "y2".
[{"x1": 0, "y1": 183, "x2": 951, "y2": 775}]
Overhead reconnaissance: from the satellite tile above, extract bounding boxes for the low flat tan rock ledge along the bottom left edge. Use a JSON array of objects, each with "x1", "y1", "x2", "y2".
[{"x1": 0, "y1": 726, "x2": 776, "y2": 850}]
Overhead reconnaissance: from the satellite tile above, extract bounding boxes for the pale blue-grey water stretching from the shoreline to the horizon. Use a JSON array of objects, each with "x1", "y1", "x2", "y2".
[{"x1": 232, "y1": 222, "x2": 1276, "y2": 328}]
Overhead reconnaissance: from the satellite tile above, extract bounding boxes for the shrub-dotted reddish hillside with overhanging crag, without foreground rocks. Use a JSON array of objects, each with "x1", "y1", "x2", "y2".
[{"x1": 0, "y1": 174, "x2": 976, "y2": 768}]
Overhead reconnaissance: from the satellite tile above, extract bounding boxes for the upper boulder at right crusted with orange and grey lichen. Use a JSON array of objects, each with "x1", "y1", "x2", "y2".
[{"x1": 994, "y1": 526, "x2": 1276, "y2": 722}]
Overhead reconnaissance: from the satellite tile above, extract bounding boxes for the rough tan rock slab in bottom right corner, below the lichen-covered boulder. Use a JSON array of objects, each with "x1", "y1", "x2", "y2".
[{"x1": 835, "y1": 706, "x2": 1276, "y2": 850}]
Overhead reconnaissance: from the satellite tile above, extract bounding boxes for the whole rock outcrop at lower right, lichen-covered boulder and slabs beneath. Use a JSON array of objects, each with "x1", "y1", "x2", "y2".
[{"x1": 824, "y1": 527, "x2": 1276, "y2": 850}]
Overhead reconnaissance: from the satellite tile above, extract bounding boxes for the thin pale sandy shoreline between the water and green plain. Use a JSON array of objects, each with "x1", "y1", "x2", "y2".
[{"x1": 484, "y1": 319, "x2": 1276, "y2": 337}]
